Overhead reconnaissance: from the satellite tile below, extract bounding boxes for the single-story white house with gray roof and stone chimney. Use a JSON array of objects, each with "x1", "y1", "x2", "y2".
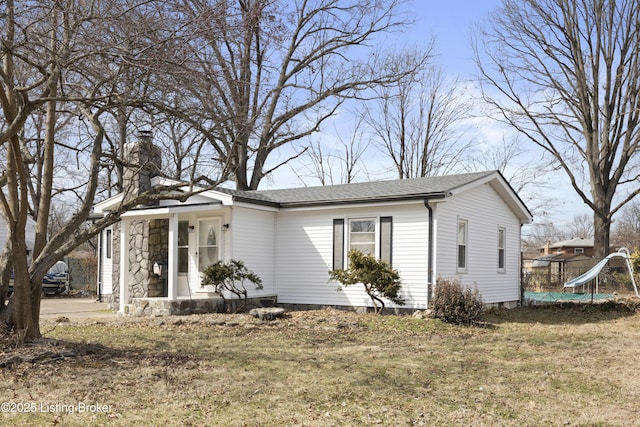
[{"x1": 94, "y1": 140, "x2": 531, "y2": 313}]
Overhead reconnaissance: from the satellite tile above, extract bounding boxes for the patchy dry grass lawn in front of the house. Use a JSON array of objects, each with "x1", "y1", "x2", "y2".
[{"x1": 0, "y1": 304, "x2": 640, "y2": 426}]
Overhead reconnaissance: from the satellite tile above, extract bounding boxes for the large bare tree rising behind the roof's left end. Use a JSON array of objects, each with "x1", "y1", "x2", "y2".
[{"x1": 156, "y1": 0, "x2": 413, "y2": 190}]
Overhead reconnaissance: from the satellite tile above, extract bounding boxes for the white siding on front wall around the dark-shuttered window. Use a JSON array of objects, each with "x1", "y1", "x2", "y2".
[{"x1": 276, "y1": 203, "x2": 428, "y2": 308}]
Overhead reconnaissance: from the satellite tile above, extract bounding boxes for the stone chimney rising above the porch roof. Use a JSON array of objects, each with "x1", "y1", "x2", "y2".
[{"x1": 122, "y1": 130, "x2": 162, "y2": 204}]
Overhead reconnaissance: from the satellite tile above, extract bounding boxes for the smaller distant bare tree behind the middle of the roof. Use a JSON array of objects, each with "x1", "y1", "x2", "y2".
[{"x1": 362, "y1": 49, "x2": 471, "y2": 179}]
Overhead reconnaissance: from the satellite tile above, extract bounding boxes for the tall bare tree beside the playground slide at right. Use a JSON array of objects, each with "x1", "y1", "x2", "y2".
[{"x1": 476, "y1": 0, "x2": 640, "y2": 257}]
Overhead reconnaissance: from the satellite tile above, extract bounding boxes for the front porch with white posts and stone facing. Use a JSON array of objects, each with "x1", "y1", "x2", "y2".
[{"x1": 113, "y1": 202, "x2": 229, "y2": 316}]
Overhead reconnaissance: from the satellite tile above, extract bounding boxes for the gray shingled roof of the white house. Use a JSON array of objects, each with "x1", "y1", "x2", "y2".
[{"x1": 223, "y1": 171, "x2": 496, "y2": 207}]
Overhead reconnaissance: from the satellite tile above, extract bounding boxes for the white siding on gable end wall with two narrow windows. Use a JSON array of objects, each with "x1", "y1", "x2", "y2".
[{"x1": 434, "y1": 184, "x2": 520, "y2": 303}]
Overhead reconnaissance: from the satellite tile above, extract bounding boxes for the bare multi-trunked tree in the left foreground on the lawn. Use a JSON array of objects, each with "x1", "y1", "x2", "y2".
[{"x1": 0, "y1": 0, "x2": 211, "y2": 339}]
